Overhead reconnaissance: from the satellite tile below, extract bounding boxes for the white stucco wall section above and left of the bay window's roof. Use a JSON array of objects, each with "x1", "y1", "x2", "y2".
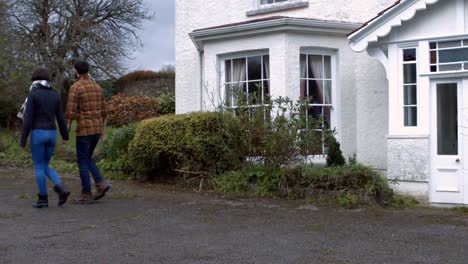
[{"x1": 176, "y1": 0, "x2": 394, "y2": 113}]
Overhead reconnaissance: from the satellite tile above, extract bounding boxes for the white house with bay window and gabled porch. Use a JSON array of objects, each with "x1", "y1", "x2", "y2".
[{"x1": 176, "y1": 0, "x2": 468, "y2": 204}]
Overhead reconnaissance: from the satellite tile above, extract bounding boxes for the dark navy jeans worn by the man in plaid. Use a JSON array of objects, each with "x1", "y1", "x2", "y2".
[{"x1": 76, "y1": 134, "x2": 104, "y2": 194}]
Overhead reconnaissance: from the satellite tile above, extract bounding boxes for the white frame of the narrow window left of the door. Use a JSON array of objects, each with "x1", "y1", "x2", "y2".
[{"x1": 398, "y1": 45, "x2": 420, "y2": 128}]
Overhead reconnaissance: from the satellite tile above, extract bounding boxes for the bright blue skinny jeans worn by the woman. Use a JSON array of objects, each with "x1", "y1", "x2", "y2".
[{"x1": 31, "y1": 129, "x2": 62, "y2": 195}]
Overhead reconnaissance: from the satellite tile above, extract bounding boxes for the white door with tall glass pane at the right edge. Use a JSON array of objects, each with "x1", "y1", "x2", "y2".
[{"x1": 430, "y1": 80, "x2": 466, "y2": 204}]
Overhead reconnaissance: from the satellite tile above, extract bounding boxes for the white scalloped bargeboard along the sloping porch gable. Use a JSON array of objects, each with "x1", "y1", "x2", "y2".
[{"x1": 348, "y1": 0, "x2": 439, "y2": 52}]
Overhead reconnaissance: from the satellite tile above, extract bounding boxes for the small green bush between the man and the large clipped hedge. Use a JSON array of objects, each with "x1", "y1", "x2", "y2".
[{"x1": 99, "y1": 124, "x2": 137, "y2": 175}]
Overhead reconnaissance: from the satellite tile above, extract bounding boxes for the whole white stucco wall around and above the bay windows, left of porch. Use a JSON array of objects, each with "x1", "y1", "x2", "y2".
[{"x1": 176, "y1": 0, "x2": 394, "y2": 170}]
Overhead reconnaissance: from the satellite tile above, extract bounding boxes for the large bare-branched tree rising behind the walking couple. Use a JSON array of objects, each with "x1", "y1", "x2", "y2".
[{"x1": 8, "y1": 0, "x2": 152, "y2": 85}]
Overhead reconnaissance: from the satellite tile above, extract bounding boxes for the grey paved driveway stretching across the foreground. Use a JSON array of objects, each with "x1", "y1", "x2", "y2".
[{"x1": 0, "y1": 167, "x2": 468, "y2": 264}]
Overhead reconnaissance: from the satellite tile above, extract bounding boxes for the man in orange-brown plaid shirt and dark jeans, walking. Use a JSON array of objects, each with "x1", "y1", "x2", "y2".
[{"x1": 66, "y1": 61, "x2": 110, "y2": 204}]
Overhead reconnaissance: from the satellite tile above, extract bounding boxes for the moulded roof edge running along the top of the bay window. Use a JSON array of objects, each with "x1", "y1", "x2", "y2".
[{"x1": 189, "y1": 16, "x2": 360, "y2": 51}]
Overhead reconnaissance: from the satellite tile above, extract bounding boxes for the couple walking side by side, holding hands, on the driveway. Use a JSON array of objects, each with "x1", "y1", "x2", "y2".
[{"x1": 18, "y1": 61, "x2": 110, "y2": 208}]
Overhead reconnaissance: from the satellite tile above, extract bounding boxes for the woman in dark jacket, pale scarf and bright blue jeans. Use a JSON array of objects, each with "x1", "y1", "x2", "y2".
[{"x1": 20, "y1": 68, "x2": 70, "y2": 208}]
